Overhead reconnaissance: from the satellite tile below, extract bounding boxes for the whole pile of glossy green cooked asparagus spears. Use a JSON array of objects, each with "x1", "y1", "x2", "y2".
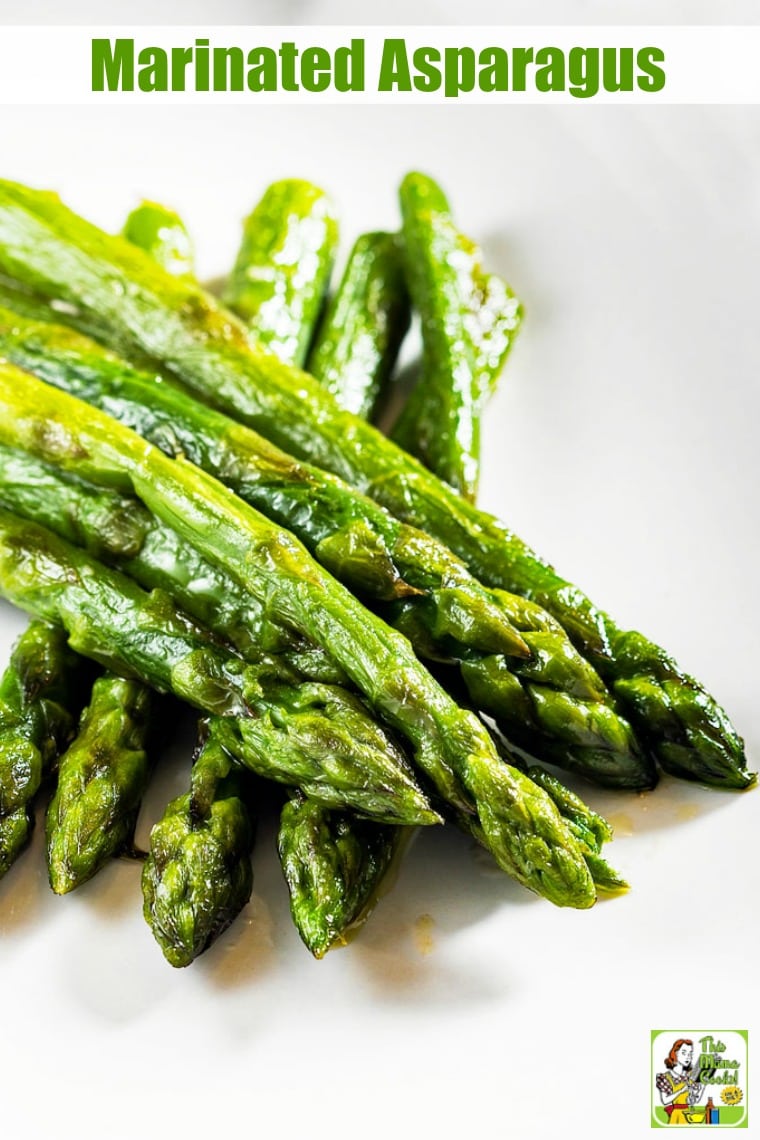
[{"x1": 0, "y1": 174, "x2": 755, "y2": 966}]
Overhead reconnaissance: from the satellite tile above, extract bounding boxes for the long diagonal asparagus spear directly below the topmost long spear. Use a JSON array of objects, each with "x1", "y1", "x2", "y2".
[{"x1": 0, "y1": 310, "x2": 529, "y2": 656}]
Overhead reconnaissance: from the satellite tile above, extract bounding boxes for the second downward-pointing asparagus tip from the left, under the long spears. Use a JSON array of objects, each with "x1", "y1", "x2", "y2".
[{"x1": 46, "y1": 674, "x2": 155, "y2": 895}]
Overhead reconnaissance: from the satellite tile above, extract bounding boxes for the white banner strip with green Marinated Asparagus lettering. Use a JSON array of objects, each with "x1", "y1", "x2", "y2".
[{"x1": 0, "y1": 25, "x2": 760, "y2": 106}]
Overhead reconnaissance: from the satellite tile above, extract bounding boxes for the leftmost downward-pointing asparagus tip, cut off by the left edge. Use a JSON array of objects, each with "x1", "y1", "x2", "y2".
[{"x1": 0, "y1": 621, "x2": 83, "y2": 878}]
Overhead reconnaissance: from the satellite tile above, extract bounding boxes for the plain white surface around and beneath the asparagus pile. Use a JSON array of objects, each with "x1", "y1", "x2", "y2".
[{"x1": 0, "y1": 2, "x2": 760, "y2": 1140}]
